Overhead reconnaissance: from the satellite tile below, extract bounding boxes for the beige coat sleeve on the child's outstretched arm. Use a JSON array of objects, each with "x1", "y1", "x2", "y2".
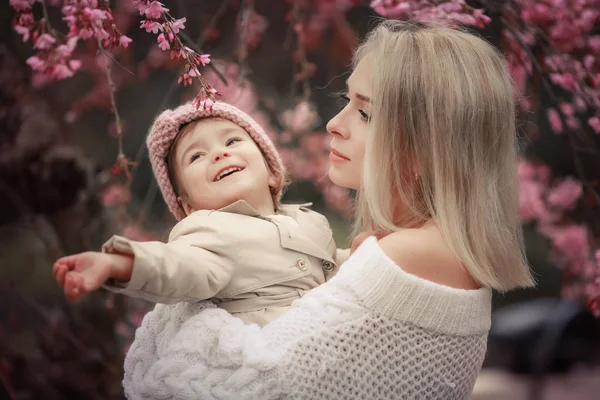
[{"x1": 102, "y1": 211, "x2": 239, "y2": 304}]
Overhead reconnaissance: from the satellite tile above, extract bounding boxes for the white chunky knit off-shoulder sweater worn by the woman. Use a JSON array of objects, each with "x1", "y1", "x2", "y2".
[{"x1": 123, "y1": 238, "x2": 491, "y2": 400}]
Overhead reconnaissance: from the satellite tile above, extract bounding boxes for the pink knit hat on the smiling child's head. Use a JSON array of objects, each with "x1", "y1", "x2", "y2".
[{"x1": 146, "y1": 101, "x2": 285, "y2": 220}]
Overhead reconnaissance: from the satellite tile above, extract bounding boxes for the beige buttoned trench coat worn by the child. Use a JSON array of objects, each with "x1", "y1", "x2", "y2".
[{"x1": 103, "y1": 200, "x2": 349, "y2": 325}]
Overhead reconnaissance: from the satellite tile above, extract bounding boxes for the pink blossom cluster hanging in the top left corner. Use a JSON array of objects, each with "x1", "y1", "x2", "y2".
[{"x1": 10, "y1": 0, "x2": 131, "y2": 82}]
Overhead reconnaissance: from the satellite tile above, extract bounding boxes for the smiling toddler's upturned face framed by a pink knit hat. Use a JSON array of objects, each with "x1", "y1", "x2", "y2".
[{"x1": 173, "y1": 119, "x2": 274, "y2": 215}]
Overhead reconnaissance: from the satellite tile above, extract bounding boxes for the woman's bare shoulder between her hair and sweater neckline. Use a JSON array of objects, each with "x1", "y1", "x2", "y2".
[{"x1": 379, "y1": 228, "x2": 480, "y2": 289}]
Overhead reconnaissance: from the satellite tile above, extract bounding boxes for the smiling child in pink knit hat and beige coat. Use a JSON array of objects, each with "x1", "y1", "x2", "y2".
[{"x1": 54, "y1": 102, "x2": 347, "y2": 326}]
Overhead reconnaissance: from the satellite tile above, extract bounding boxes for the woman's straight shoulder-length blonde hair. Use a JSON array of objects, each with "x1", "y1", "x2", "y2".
[{"x1": 355, "y1": 21, "x2": 534, "y2": 291}]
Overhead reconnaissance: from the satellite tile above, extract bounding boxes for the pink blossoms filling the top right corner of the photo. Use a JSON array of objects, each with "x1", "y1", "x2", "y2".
[{"x1": 507, "y1": 0, "x2": 600, "y2": 133}]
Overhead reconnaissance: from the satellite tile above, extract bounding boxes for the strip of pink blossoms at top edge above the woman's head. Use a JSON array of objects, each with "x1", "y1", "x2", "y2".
[{"x1": 371, "y1": 0, "x2": 490, "y2": 28}]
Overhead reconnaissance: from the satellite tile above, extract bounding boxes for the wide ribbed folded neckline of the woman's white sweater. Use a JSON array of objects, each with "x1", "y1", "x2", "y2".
[{"x1": 336, "y1": 236, "x2": 492, "y2": 336}]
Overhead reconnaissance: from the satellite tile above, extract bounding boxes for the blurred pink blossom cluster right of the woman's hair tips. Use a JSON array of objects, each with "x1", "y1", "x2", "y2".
[{"x1": 519, "y1": 160, "x2": 600, "y2": 315}]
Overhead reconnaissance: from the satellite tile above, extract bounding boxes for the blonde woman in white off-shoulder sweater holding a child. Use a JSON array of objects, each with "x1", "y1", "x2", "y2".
[{"x1": 124, "y1": 22, "x2": 533, "y2": 399}]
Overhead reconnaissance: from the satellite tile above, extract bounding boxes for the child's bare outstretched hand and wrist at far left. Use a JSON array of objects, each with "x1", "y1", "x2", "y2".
[{"x1": 53, "y1": 251, "x2": 133, "y2": 301}]
